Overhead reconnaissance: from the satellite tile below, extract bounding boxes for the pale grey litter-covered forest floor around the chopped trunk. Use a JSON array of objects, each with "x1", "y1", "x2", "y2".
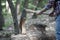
[{"x1": 1, "y1": 10, "x2": 55, "y2": 40}]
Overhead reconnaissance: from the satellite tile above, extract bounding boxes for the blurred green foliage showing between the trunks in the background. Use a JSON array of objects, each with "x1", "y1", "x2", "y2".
[{"x1": 2, "y1": 0, "x2": 48, "y2": 27}]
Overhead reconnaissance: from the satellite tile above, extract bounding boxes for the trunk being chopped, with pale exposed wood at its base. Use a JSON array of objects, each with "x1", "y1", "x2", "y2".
[{"x1": 19, "y1": 0, "x2": 28, "y2": 34}]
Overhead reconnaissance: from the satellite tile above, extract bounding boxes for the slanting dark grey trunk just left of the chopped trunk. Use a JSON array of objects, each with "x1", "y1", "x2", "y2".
[{"x1": 7, "y1": 0, "x2": 19, "y2": 34}]
